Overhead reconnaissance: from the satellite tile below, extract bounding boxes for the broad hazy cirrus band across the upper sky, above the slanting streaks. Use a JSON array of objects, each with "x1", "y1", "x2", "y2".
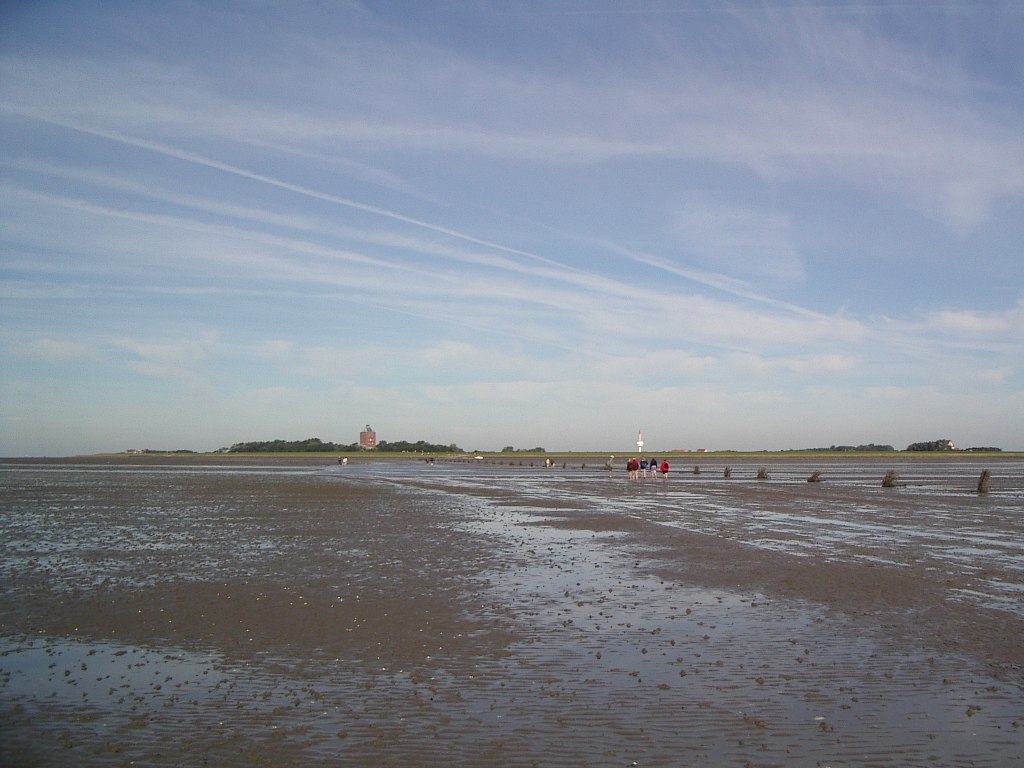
[{"x1": 4, "y1": 2, "x2": 1024, "y2": 229}]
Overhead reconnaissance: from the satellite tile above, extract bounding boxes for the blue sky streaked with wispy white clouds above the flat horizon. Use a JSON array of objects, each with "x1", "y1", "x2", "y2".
[{"x1": 0, "y1": 0, "x2": 1024, "y2": 456}]
